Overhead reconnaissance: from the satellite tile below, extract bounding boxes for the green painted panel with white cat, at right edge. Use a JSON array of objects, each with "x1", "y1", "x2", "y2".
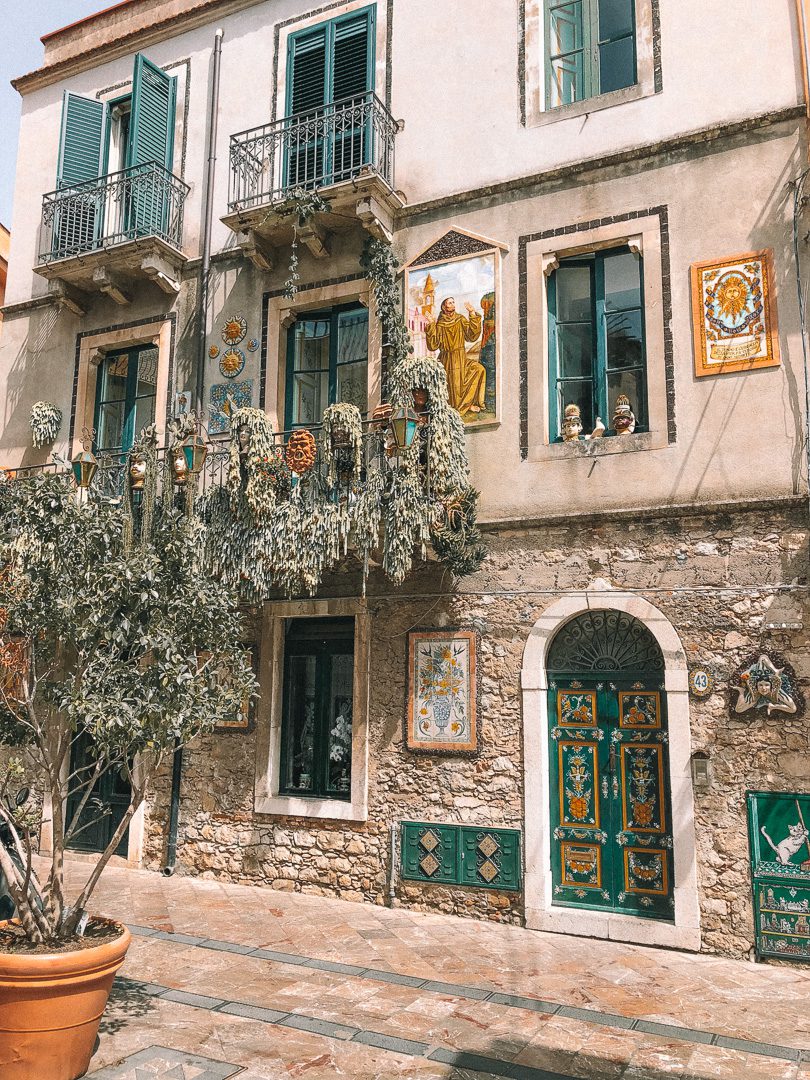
[{"x1": 747, "y1": 792, "x2": 810, "y2": 961}]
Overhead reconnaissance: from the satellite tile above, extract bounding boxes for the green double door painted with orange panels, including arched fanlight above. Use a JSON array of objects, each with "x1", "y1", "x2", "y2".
[{"x1": 546, "y1": 610, "x2": 675, "y2": 921}]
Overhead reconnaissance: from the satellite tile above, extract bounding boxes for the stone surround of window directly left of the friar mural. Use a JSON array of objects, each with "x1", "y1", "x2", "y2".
[{"x1": 264, "y1": 278, "x2": 382, "y2": 431}]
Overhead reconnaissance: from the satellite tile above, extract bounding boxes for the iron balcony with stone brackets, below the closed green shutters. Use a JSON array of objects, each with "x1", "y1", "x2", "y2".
[{"x1": 222, "y1": 92, "x2": 404, "y2": 269}]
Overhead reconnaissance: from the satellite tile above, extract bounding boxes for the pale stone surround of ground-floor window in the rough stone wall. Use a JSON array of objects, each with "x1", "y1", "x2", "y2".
[{"x1": 254, "y1": 599, "x2": 372, "y2": 822}]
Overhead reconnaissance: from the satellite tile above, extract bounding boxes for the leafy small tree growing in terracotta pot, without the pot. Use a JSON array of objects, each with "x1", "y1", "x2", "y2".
[{"x1": 0, "y1": 474, "x2": 254, "y2": 942}]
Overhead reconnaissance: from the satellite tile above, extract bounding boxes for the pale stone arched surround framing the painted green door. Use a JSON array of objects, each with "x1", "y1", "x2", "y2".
[{"x1": 521, "y1": 580, "x2": 701, "y2": 951}]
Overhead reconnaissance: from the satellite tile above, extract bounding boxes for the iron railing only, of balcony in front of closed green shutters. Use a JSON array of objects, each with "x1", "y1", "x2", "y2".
[{"x1": 228, "y1": 93, "x2": 397, "y2": 212}]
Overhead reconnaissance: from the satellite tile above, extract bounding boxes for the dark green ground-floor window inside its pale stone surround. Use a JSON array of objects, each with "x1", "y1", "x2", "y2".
[{"x1": 279, "y1": 618, "x2": 354, "y2": 801}]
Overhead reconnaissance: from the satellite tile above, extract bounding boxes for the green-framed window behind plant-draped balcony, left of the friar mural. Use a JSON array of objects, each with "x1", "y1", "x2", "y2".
[{"x1": 284, "y1": 303, "x2": 368, "y2": 430}]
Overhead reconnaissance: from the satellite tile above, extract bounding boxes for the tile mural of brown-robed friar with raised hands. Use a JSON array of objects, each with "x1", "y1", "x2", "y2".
[{"x1": 405, "y1": 238, "x2": 500, "y2": 427}]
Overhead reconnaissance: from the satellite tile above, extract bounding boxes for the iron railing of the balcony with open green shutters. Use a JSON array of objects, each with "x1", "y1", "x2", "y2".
[{"x1": 39, "y1": 162, "x2": 189, "y2": 262}]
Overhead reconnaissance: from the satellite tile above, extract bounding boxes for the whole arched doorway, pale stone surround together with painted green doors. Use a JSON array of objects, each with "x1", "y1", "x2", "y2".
[{"x1": 521, "y1": 580, "x2": 700, "y2": 949}]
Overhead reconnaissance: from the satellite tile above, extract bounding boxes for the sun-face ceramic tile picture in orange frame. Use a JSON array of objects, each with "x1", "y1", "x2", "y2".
[{"x1": 692, "y1": 252, "x2": 780, "y2": 376}]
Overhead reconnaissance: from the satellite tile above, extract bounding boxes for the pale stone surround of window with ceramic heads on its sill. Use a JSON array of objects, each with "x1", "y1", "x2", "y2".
[{"x1": 526, "y1": 215, "x2": 670, "y2": 461}]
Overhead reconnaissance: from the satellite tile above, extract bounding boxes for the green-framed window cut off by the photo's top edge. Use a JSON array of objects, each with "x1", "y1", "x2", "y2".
[{"x1": 544, "y1": 0, "x2": 638, "y2": 109}]
